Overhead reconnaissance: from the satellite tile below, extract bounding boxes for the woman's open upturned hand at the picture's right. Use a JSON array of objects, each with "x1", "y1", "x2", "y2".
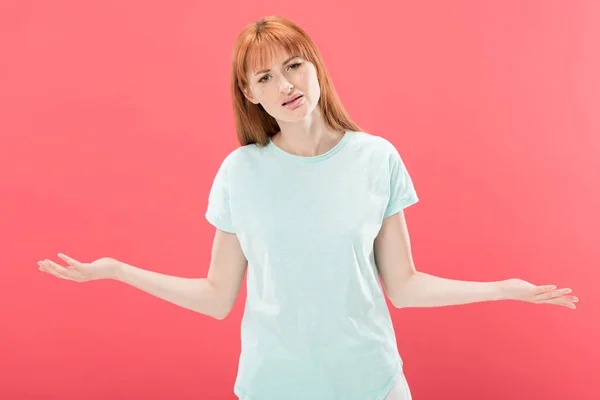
[{"x1": 500, "y1": 278, "x2": 579, "y2": 309}]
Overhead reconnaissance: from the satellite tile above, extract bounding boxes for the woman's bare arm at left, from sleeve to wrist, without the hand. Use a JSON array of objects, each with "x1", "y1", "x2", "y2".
[{"x1": 114, "y1": 229, "x2": 247, "y2": 319}]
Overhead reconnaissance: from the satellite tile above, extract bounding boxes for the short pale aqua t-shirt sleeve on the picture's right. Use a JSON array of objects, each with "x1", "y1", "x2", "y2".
[{"x1": 383, "y1": 145, "x2": 419, "y2": 218}]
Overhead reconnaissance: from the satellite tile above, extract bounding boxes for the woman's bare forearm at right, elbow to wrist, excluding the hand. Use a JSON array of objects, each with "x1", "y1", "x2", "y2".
[{"x1": 393, "y1": 271, "x2": 503, "y2": 308}]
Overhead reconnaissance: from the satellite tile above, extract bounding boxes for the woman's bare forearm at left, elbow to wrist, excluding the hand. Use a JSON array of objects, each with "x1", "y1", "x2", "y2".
[{"x1": 115, "y1": 263, "x2": 224, "y2": 319}]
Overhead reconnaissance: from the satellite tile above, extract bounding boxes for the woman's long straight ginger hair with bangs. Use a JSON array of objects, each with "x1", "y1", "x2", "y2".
[{"x1": 231, "y1": 16, "x2": 360, "y2": 147}]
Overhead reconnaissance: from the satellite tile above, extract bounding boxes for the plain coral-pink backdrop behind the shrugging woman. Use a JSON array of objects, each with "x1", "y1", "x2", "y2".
[{"x1": 0, "y1": 0, "x2": 600, "y2": 400}]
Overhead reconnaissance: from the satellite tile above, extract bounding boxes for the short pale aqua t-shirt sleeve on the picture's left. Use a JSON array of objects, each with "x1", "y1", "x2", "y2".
[{"x1": 204, "y1": 158, "x2": 235, "y2": 233}]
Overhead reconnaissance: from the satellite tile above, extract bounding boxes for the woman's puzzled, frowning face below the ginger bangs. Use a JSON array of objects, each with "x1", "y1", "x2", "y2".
[{"x1": 243, "y1": 47, "x2": 321, "y2": 122}]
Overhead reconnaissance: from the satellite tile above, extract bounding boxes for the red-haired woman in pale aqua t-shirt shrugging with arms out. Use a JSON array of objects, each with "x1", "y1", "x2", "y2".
[{"x1": 40, "y1": 17, "x2": 577, "y2": 400}]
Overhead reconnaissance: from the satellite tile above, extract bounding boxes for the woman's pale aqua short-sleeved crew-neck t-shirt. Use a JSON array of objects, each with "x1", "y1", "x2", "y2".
[{"x1": 206, "y1": 131, "x2": 418, "y2": 400}]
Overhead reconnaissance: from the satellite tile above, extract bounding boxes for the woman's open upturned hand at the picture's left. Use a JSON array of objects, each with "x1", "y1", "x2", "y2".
[{"x1": 38, "y1": 254, "x2": 124, "y2": 282}]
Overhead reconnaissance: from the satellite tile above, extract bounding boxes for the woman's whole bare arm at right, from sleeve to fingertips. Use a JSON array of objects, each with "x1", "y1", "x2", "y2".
[{"x1": 374, "y1": 210, "x2": 579, "y2": 308}]
